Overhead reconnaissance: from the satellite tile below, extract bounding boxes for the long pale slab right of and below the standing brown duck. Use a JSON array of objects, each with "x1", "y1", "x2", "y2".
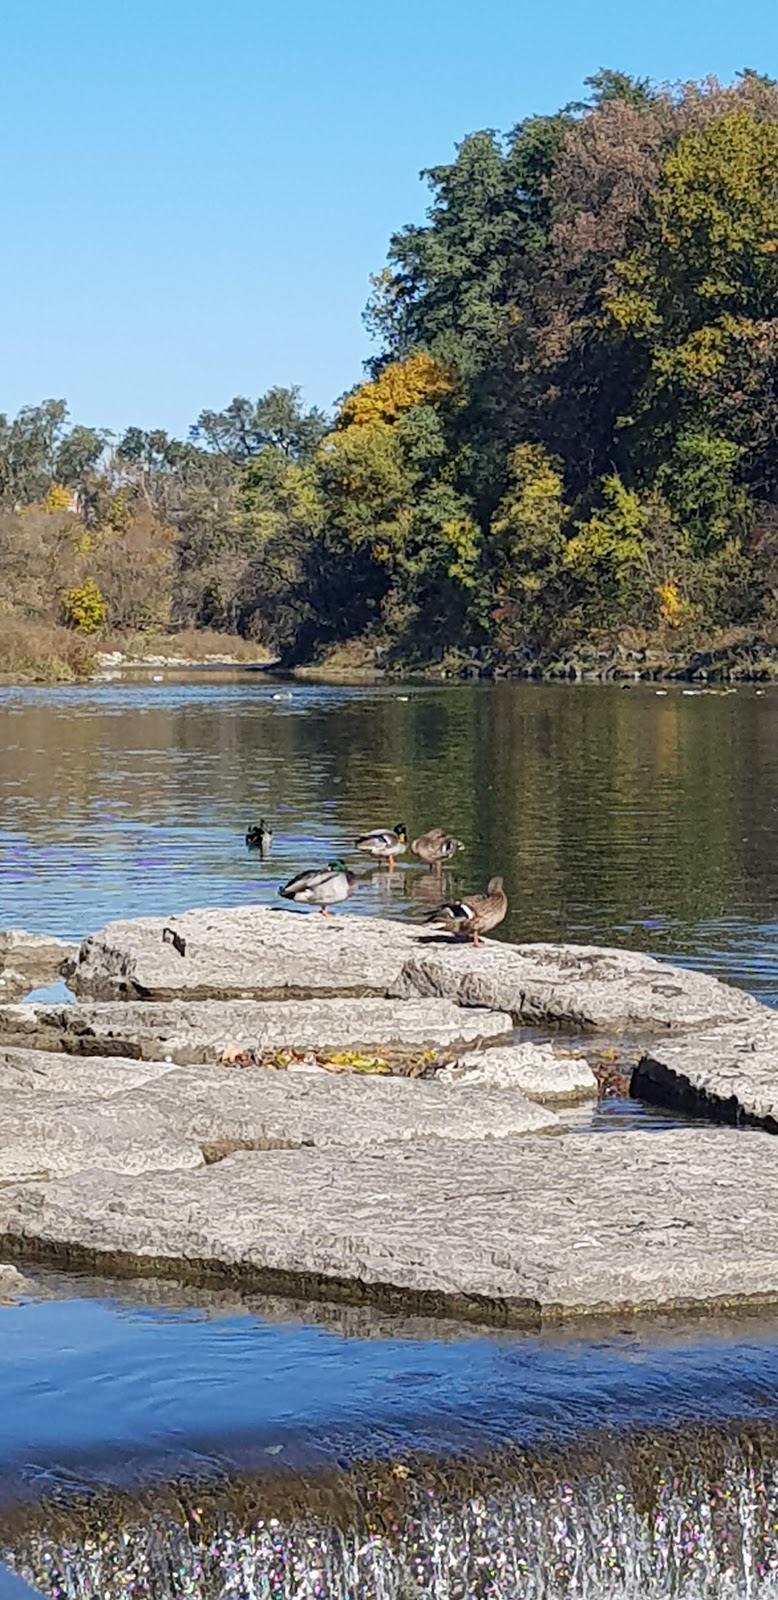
[{"x1": 392, "y1": 942, "x2": 760, "y2": 1034}]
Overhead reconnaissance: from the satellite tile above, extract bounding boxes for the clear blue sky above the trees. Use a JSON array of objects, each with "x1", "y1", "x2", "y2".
[{"x1": 0, "y1": 0, "x2": 778, "y2": 432}]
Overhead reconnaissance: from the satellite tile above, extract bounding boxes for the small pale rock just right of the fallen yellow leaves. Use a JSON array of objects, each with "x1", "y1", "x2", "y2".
[{"x1": 435, "y1": 1043, "x2": 597, "y2": 1106}]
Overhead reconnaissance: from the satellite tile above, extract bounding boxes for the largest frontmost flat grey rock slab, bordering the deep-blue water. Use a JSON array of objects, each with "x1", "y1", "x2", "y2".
[{"x1": 0, "y1": 1128, "x2": 778, "y2": 1325}]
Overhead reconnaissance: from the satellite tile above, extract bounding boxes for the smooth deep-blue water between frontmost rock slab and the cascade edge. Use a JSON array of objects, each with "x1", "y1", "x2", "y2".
[{"x1": 0, "y1": 1280, "x2": 778, "y2": 1499}]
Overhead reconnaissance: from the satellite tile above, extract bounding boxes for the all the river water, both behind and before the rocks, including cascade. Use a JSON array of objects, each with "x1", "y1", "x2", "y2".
[{"x1": 0, "y1": 672, "x2": 778, "y2": 1600}]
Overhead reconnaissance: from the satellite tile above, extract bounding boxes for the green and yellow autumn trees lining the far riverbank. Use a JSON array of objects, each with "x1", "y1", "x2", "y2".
[{"x1": 0, "y1": 70, "x2": 778, "y2": 664}]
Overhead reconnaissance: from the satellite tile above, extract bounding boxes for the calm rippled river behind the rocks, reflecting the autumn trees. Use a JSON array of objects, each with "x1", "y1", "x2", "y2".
[{"x1": 0, "y1": 675, "x2": 778, "y2": 1000}]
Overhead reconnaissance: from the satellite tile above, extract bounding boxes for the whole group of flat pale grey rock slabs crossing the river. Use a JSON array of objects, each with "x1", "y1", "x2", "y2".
[{"x1": 0, "y1": 907, "x2": 778, "y2": 1326}]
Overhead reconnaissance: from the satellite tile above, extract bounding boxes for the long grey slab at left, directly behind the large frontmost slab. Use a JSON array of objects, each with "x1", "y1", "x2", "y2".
[{"x1": 0, "y1": 1048, "x2": 559, "y2": 1182}]
